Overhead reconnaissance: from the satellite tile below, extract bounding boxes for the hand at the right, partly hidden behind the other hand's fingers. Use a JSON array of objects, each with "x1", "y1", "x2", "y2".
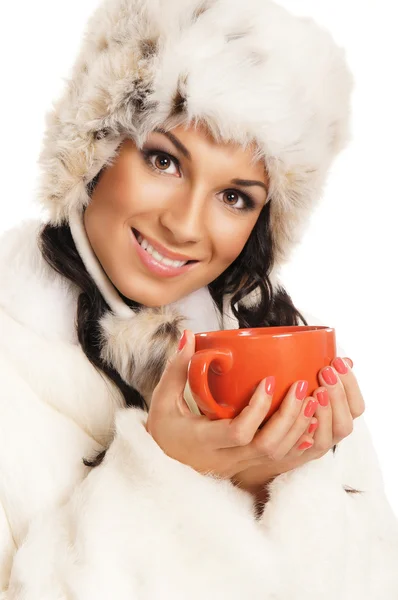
[{"x1": 233, "y1": 358, "x2": 365, "y2": 493}]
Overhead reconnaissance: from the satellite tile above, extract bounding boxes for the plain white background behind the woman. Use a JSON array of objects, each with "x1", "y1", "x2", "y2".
[{"x1": 0, "y1": 0, "x2": 398, "y2": 515}]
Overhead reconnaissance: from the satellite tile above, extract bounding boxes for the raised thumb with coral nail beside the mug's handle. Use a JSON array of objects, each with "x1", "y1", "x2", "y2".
[{"x1": 152, "y1": 329, "x2": 195, "y2": 409}]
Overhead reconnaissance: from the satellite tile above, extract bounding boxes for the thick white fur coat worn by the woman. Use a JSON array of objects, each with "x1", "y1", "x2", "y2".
[{"x1": 0, "y1": 222, "x2": 398, "y2": 600}]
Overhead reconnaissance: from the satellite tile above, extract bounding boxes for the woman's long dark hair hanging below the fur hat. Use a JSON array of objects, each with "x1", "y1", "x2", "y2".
[{"x1": 39, "y1": 180, "x2": 307, "y2": 466}]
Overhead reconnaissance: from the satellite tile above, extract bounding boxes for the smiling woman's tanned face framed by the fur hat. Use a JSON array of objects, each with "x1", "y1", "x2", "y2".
[{"x1": 84, "y1": 126, "x2": 268, "y2": 307}]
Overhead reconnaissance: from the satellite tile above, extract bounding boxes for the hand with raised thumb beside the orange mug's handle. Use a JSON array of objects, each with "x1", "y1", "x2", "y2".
[{"x1": 146, "y1": 330, "x2": 322, "y2": 479}]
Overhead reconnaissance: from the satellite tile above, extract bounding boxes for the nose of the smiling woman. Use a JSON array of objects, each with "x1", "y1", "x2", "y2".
[{"x1": 160, "y1": 188, "x2": 207, "y2": 245}]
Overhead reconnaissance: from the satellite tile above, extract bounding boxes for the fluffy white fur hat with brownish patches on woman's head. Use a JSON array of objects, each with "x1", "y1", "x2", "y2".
[{"x1": 39, "y1": 0, "x2": 352, "y2": 278}]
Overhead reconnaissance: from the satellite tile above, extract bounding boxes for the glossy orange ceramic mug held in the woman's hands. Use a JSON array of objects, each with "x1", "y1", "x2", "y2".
[{"x1": 188, "y1": 326, "x2": 336, "y2": 422}]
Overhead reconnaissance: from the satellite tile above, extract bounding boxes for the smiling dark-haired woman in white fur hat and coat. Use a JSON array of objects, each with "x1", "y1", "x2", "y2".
[{"x1": 0, "y1": 0, "x2": 398, "y2": 600}]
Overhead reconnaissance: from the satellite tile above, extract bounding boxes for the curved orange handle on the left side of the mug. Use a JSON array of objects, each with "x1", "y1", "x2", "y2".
[{"x1": 188, "y1": 349, "x2": 237, "y2": 420}]
